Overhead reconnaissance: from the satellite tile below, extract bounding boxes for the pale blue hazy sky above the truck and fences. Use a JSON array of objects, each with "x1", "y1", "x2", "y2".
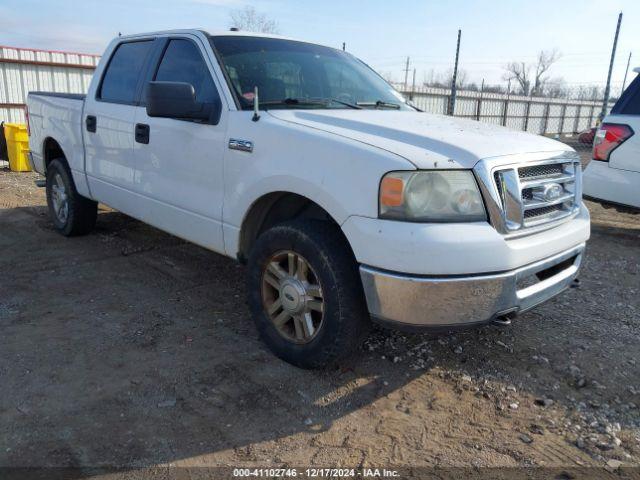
[{"x1": 0, "y1": 0, "x2": 640, "y2": 93}]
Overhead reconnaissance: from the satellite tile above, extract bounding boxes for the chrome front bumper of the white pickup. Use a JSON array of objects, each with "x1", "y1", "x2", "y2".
[{"x1": 360, "y1": 243, "x2": 585, "y2": 328}]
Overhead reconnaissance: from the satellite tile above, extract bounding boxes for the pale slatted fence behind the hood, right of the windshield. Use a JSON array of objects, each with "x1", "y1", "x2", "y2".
[{"x1": 396, "y1": 85, "x2": 613, "y2": 135}]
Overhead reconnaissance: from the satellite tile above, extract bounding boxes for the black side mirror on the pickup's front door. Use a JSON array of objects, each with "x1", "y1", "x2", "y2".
[{"x1": 147, "y1": 82, "x2": 222, "y2": 125}]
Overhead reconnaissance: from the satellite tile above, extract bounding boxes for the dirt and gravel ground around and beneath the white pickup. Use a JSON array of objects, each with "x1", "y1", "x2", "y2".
[{"x1": 0, "y1": 170, "x2": 640, "y2": 478}]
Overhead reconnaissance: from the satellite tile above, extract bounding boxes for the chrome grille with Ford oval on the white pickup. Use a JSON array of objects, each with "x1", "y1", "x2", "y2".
[{"x1": 475, "y1": 152, "x2": 582, "y2": 234}]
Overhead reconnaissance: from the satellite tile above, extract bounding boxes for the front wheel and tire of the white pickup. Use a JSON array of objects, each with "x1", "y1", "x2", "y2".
[{"x1": 248, "y1": 220, "x2": 369, "y2": 368}]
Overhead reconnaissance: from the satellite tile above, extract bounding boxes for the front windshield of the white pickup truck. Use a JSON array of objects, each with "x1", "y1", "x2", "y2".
[{"x1": 211, "y1": 36, "x2": 411, "y2": 110}]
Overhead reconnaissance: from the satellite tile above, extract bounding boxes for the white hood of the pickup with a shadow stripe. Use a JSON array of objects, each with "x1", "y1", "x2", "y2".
[{"x1": 269, "y1": 110, "x2": 571, "y2": 169}]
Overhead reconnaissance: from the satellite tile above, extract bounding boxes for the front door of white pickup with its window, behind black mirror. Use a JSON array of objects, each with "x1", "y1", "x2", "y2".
[{"x1": 133, "y1": 35, "x2": 228, "y2": 252}]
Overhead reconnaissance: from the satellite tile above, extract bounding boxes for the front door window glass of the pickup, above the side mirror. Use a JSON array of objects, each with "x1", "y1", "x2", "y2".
[{"x1": 154, "y1": 39, "x2": 218, "y2": 103}]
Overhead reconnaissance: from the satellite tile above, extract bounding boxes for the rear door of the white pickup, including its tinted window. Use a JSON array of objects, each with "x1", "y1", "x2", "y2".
[{"x1": 82, "y1": 39, "x2": 153, "y2": 208}]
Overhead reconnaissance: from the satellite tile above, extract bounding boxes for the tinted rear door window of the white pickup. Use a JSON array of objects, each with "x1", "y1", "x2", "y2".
[{"x1": 98, "y1": 40, "x2": 153, "y2": 104}]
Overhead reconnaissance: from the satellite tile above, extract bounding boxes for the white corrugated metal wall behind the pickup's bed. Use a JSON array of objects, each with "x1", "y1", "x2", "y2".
[{"x1": 0, "y1": 46, "x2": 100, "y2": 123}]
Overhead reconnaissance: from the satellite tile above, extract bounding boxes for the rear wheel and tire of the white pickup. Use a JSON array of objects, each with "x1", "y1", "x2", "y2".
[{"x1": 46, "y1": 159, "x2": 98, "y2": 237}]
